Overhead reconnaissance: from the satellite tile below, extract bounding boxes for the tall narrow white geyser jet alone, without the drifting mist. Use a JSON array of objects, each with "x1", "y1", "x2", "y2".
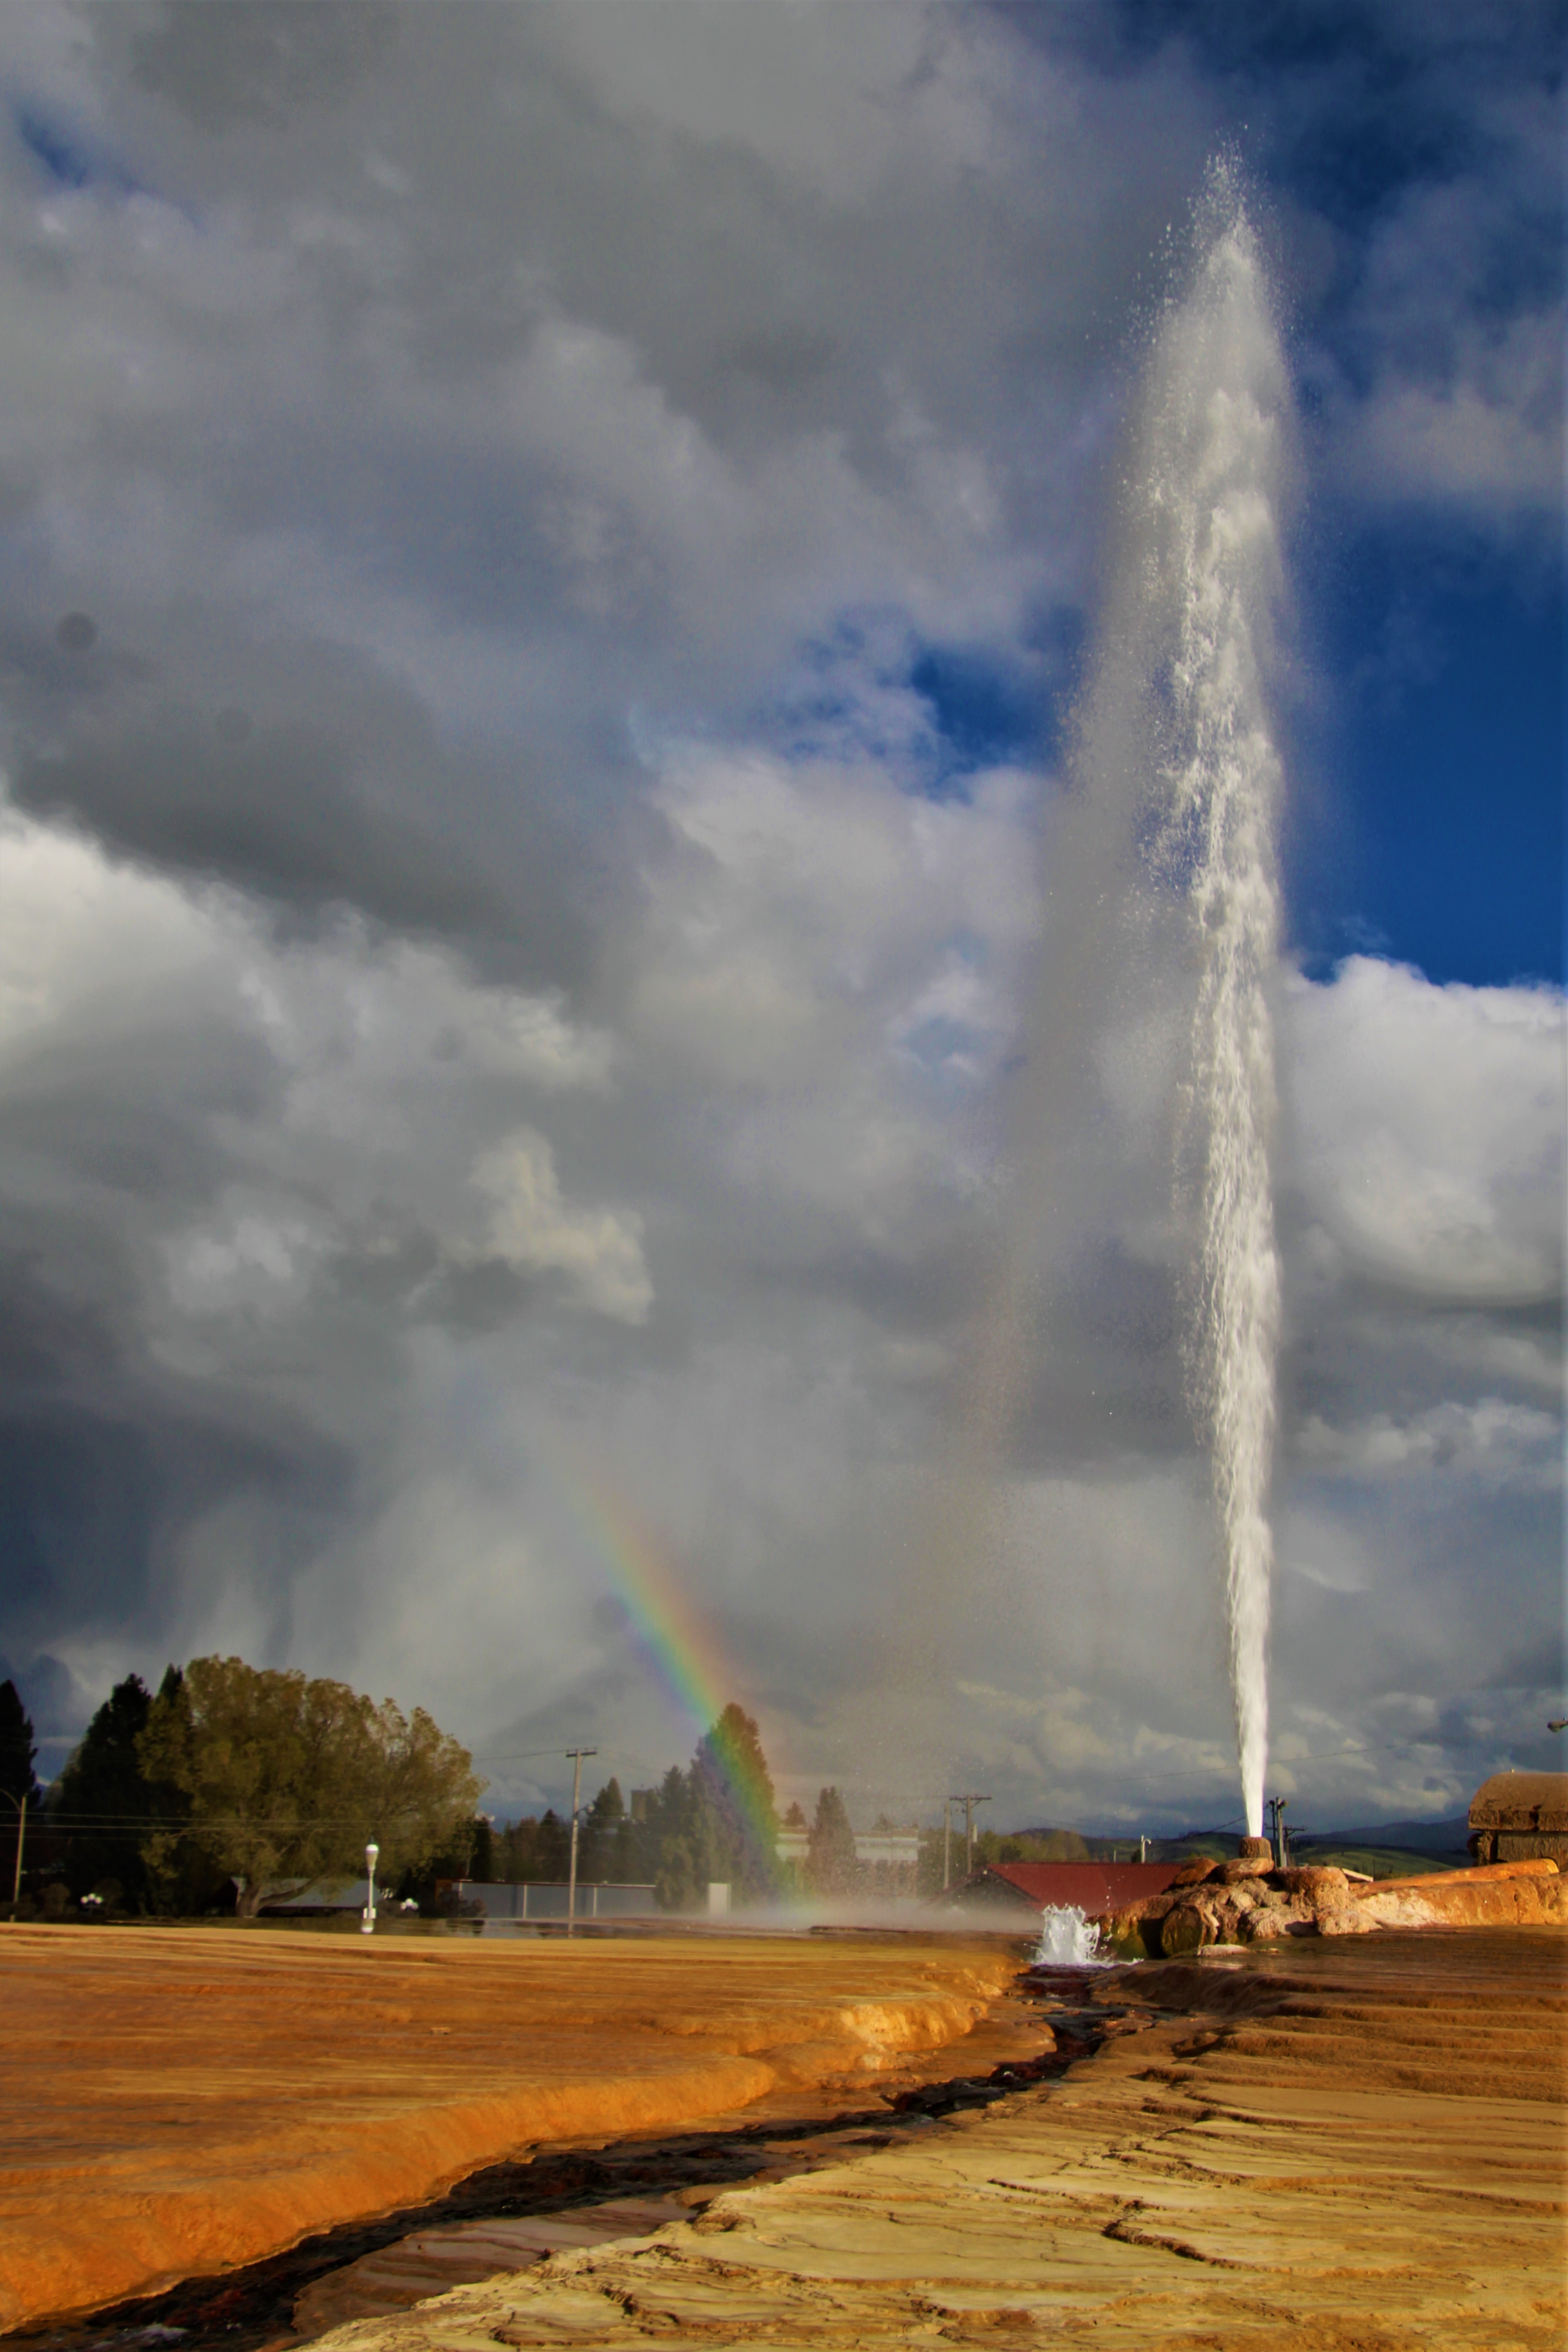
[{"x1": 1143, "y1": 169, "x2": 1291, "y2": 1837}]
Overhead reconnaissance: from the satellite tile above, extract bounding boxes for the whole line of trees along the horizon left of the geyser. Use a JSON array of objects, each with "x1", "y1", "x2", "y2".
[{"x1": 0, "y1": 1658, "x2": 940, "y2": 1917}]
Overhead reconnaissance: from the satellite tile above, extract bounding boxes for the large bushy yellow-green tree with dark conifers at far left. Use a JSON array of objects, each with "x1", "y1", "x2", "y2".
[{"x1": 0, "y1": 1658, "x2": 482, "y2": 1917}]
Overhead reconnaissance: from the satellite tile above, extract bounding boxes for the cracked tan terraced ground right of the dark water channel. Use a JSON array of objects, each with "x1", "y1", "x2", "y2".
[{"x1": 320, "y1": 1929, "x2": 1568, "y2": 2352}]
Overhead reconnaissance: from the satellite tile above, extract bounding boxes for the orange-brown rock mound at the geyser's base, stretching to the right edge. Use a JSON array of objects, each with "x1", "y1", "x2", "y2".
[{"x1": 1100, "y1": 1853, "x2": 1568, "y2": 1959}]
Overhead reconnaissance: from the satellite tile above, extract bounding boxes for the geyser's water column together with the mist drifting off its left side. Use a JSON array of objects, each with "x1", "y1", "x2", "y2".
[{"x1": 1037, "y1": 167, "x2": 1295, "y2": 1834}]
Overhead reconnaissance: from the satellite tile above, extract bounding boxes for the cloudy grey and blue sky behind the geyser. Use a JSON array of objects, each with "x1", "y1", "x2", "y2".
[{"x1": 0, "y1": 0, "x2": 1563, "y2": 1828}]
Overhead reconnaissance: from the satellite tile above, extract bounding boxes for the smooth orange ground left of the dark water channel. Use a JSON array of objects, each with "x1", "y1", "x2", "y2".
[{"x1": 0, "y1": 1924, "x2": 1018, "y2": 2329}]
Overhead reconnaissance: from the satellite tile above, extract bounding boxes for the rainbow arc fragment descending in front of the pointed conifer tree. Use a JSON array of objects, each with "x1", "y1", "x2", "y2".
[{"x1": 560, "y1": 1470, "x2": 778, "y2": 1879}]
